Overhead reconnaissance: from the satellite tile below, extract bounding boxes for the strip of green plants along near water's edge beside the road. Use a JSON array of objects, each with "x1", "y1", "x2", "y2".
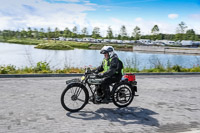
[{"x1": 0, "y1": 62, "x2": 200, "y2": 74}]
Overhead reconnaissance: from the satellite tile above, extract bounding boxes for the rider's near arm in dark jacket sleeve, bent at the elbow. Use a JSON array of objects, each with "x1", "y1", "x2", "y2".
[{"x1": 103, "y1": 58, "x2": 119, "y2": 77}]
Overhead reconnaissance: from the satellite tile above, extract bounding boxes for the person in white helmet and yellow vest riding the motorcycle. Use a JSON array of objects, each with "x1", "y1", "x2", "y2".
[{"x1": 93, "y1": 46, "x2": 123, "y2": 103}]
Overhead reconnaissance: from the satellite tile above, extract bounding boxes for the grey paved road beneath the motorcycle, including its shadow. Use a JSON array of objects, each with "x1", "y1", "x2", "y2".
[{"x1": 0, "y1": 75, "x2": 200, "y2": 133}]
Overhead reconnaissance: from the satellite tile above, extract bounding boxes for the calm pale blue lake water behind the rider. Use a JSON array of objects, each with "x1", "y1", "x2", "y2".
[{"x1": 0, "y1": 43, "x2": 200, "y2": 69}]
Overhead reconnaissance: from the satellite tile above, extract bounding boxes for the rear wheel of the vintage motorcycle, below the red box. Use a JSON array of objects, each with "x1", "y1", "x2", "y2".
[{"x1": 112, "y1": 83, "x2": 135, "y2": 108}]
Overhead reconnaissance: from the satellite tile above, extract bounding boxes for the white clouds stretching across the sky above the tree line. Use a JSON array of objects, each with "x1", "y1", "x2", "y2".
[{"x1": 0, "y1": 0, "x2": 200, "y2": 36}]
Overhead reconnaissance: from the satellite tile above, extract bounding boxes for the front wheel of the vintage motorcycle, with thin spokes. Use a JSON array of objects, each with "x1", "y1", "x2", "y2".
[{"x1": 61, "y1": 83, "x2": 89, "y2": 112}]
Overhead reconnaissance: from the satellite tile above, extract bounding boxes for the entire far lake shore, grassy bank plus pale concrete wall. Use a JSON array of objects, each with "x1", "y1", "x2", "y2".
[{"x1": 0, "y1": 40, "x2": 200, "y2": 55}]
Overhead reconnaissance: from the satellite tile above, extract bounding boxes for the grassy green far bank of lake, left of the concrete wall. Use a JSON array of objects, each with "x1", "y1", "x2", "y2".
[{"x1": 0, "y1": 39, "x2": 133, "y2": 51}]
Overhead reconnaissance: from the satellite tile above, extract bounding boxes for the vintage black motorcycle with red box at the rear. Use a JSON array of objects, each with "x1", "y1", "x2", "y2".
[{"x1": 61, "y1": 68, "x2": 138, "y2": 112}]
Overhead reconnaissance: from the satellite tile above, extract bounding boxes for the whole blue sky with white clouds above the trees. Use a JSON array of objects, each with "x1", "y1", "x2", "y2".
[{"x1": 0, "y1": 0, "x2": 200, "y2": 36}]
